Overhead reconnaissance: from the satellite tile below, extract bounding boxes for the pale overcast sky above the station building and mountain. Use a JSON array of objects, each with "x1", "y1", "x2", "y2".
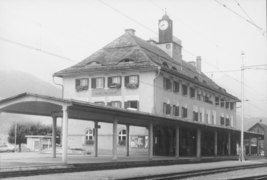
[{"x1": 0, "y1": 0, "x2": 267, "y2": 117}]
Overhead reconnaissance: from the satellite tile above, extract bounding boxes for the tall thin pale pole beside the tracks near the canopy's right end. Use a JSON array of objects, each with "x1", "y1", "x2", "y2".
[{"x1": 240, "y1": 51, "x2": 245, "y2": 162}]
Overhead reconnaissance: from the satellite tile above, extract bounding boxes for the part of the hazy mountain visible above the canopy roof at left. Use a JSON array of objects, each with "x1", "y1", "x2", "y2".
[{"x1": 0, "y1": 70, "x2": 61, "y2": 99}]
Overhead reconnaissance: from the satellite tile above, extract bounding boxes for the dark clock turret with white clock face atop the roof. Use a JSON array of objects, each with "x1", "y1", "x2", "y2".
[{"x1": 158, "y1": 14, "x2": 173, "y2": 44}]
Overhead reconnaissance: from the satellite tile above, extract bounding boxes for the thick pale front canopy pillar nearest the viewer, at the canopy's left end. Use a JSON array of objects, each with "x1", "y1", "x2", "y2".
[{"x1": 62, "y1": 106, "x2": 68, "y2": 164}]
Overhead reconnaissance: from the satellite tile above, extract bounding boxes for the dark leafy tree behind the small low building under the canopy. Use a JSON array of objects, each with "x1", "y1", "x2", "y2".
[{"x1": 8, "y1": 122, "x2": 61, "y2": 152}]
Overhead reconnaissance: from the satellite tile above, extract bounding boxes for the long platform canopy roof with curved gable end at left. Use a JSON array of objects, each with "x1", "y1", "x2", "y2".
[{"x1": 0, "y1": 93, "x2": 262, "y2": 136}]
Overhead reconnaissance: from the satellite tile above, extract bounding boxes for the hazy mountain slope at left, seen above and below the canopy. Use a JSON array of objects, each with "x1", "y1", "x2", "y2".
[{"x1": 0, "y1": 70, "x2": 61, "y2": 143}]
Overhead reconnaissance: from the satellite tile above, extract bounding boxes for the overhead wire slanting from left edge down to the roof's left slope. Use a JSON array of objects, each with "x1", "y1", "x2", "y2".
[{"x1": 0, "y1": 37, "x2": 75, "y2": 62}]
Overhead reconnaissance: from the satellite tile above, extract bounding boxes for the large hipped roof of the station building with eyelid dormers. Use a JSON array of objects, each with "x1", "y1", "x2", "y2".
[{"x1": 54, "y1": 33, "x2": 238, "y2": 100}]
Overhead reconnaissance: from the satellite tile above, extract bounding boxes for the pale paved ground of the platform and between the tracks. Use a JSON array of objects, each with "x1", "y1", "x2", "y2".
[{"x1": 0, "y1": 153, "x2": 267, "y2": 180}]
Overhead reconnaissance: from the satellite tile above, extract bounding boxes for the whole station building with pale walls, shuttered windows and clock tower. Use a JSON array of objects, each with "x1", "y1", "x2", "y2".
[{"x1": 53, "y1": 14, "x2": 240, "y2": 156}]
